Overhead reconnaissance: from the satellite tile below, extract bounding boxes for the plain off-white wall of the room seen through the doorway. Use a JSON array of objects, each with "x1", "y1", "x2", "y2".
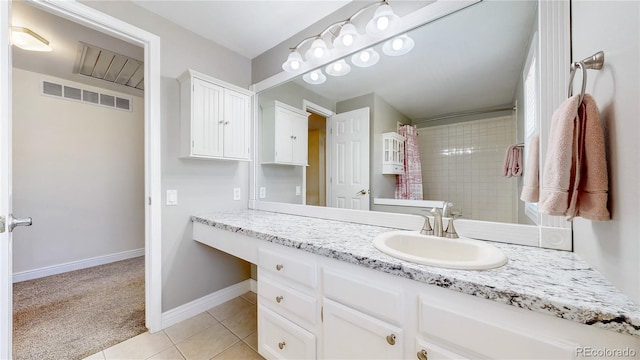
[{"x1": 13, "y1": 68, "x2": 144, "y2": 273}]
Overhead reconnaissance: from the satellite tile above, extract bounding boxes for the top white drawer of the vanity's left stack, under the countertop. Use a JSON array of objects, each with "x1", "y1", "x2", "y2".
[{"x1": 258, "y1": 248, "x2": 317, "y2": 288}]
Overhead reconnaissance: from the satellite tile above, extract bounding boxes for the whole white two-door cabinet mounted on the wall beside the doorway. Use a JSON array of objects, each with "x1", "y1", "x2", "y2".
[{"x1": 178, "y1": 70, "x2": 253, "y2": 160}]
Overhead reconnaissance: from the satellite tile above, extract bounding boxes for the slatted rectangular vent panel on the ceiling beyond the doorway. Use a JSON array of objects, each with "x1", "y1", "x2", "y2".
[{"x1": 74, "y1": 42, "x2": 144, "y2": 90}]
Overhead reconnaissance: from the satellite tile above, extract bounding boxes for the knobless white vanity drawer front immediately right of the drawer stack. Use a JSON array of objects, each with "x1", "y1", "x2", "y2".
[{"x1": 323, "y1": 269, "x2": 404, "y2": 325}]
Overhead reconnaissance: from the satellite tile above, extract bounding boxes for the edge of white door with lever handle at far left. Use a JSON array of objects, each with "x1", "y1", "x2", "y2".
[{"x1": 0, "y1": 1, "x2": 13, "y2": 359}]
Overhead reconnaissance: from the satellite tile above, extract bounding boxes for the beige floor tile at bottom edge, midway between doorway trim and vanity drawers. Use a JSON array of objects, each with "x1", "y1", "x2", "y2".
[{"x1": 176, "y1": 324, "x2": 240, "y2": 360}]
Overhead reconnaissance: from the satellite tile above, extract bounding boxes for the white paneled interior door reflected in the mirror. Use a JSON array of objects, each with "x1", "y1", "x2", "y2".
[{"x1": 329, "y1": 107, "x2": 369, "y2": 210}]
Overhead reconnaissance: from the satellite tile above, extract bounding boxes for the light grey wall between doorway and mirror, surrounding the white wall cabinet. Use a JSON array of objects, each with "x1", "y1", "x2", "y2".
[{"x1": 85, "y1": 1, "x2": 251, "y2": 311}]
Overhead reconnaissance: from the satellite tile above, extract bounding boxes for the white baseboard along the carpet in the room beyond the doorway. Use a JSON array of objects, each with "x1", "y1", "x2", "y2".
[{"x1": 13, "y1": 248, "x2": 144, "y2": 283}]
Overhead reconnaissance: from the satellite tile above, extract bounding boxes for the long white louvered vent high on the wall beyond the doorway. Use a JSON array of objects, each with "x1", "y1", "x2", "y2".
[{"x1": 42, "y1": 81, "x2": 131, "y2": 111}]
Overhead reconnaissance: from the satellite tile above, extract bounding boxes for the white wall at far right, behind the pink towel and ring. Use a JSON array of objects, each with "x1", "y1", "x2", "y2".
[{"x1": 571, "y1": 1, "x2": 640, "y2": 304}]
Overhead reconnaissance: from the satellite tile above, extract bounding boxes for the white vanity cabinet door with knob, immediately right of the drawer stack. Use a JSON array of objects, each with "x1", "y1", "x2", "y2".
[{"x1": 323, "y1": 298, "x2": 404, "y2": 359}]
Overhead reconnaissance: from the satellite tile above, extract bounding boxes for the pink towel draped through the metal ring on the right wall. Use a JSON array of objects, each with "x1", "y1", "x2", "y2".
[{"x1": 539, "y1": 94, "x2": 610, "y2": 221}]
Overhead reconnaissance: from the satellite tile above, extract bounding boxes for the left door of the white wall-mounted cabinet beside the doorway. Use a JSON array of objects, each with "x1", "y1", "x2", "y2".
[{"x1": 191, "y1": 78, "x2": 223, "y2": 156}]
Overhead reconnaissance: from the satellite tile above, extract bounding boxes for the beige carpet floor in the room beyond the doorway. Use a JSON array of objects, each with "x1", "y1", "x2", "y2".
[{"x1": 13, "y1": 257, "x2": 146, "y2": 360}]
